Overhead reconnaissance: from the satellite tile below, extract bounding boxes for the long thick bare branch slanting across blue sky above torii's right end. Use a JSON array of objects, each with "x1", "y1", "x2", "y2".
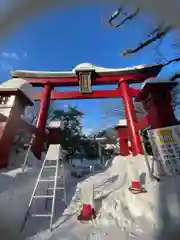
[{"x1": 122, "y1": 26, "x2": 172, "y2": 56}]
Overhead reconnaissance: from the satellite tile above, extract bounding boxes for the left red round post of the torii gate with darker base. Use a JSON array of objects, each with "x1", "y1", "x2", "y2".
[{"x1": 32, "y1": 83, "x2": 52, "y2": 159}]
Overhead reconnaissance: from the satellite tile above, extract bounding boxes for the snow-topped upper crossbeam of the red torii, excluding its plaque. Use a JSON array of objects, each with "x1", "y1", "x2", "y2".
[{"x1": 11, "y1": 63, "x2": 162, "y2": 87}]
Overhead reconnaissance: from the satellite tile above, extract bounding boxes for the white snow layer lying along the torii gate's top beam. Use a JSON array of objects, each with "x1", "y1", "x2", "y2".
[{"x1": 11, "y1": 63, "x2": 160, "y2": 78}]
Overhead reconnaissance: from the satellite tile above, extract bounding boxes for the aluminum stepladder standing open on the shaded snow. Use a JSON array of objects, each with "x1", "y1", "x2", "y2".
[{"x1": 21, "y1": 144, "x2": 67, "y2": 232}]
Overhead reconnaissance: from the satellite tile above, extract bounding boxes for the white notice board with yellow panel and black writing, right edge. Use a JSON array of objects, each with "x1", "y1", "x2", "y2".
[{"x1": 148, "y1": 125, "x2": 180, "y2": 175}]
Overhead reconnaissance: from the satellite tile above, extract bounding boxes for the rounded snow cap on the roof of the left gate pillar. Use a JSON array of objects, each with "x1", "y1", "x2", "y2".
[{"x1": 0, "y1": 78, "x2": 37, "y2": 101}]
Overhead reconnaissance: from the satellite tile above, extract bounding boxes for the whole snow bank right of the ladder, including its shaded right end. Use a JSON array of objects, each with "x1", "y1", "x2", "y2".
[{"x1": 66, "y1": 155, "x2": 180, "y2": 239}]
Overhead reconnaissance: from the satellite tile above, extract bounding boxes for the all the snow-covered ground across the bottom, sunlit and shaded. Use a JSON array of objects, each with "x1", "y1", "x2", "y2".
[{"x1": 0, "y1": 150, "x2": 180, "y2": 240}]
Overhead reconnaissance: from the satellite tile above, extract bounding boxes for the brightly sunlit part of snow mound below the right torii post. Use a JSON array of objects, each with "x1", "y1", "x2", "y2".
[{"x1": 97, "y1": 156, "x2": 158, "y2": 228}]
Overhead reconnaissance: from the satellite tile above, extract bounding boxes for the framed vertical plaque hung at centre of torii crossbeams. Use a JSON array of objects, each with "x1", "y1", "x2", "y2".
[{"x1": 79, "y1": 72, "x2": 92, "y2": 93}]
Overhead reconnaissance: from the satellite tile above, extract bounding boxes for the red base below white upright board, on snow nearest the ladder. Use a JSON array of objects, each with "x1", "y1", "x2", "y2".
[{"x1": 78, "y1": 204, "x2": 96, "y2": 221}]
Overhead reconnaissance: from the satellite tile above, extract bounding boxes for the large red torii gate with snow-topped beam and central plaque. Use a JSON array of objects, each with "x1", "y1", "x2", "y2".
[{"x1": 12, "y1": 63, "x2": 163, "y2": 159}]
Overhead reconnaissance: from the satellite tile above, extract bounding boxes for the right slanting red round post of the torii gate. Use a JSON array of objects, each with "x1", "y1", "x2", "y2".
[{"x1": 120, "y1": 81, "x2": 143, "y2": 156}]
